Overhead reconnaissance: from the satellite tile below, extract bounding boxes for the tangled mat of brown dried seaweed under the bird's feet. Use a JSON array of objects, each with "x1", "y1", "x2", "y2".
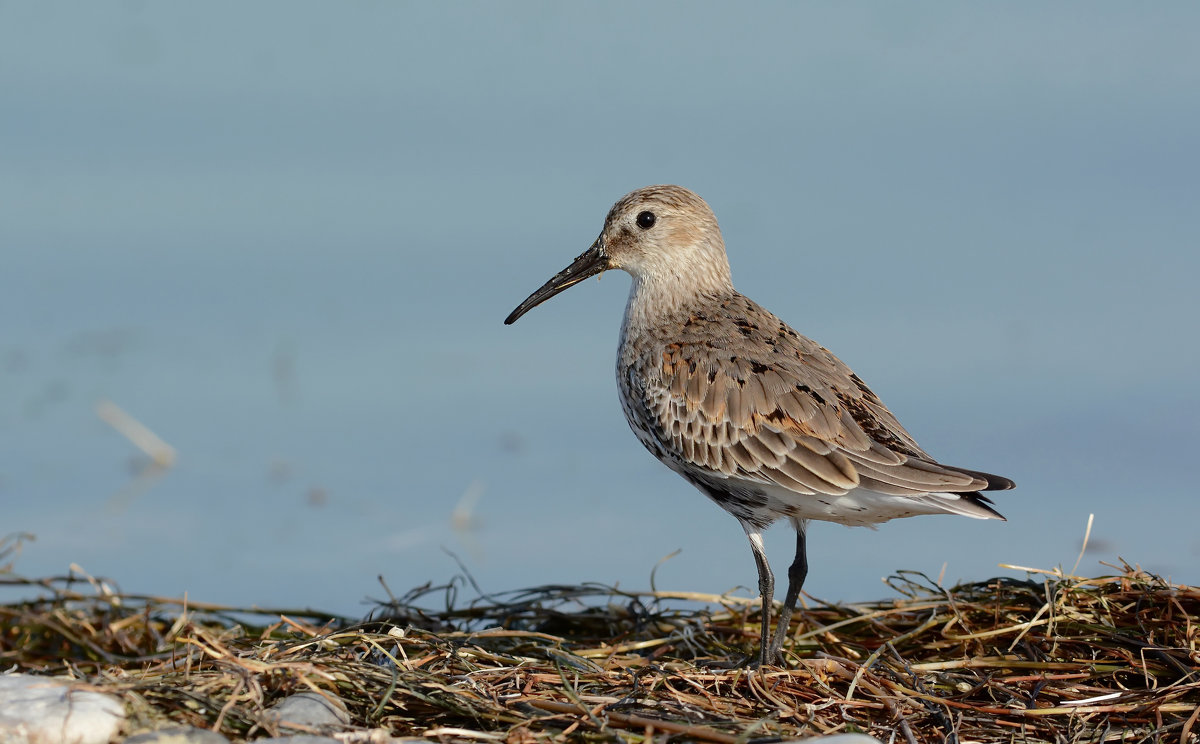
[{"x1": 0, "y1": 556, "x2": 1200, "y2": 743}]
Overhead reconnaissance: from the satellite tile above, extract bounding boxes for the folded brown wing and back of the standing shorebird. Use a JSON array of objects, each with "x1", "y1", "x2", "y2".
[{"x1": 623, "y1": 290, "x2": 1012, "y2": 510}]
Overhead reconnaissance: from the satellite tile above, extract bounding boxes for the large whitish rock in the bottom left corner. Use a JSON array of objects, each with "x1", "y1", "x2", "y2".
[{"x1": 0, "y1": 674, "x2": 125, "y2": 744}]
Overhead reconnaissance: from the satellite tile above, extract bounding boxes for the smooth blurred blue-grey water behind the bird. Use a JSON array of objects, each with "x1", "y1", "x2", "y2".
[{"x1": 0, "y1": 1, "x2": 1200, "y2": 614}]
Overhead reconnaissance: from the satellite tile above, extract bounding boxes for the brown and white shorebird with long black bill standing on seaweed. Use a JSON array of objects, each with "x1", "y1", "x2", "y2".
[{"x1": 504, "y1": 186, "x2": 1014, "y2": 665}]
